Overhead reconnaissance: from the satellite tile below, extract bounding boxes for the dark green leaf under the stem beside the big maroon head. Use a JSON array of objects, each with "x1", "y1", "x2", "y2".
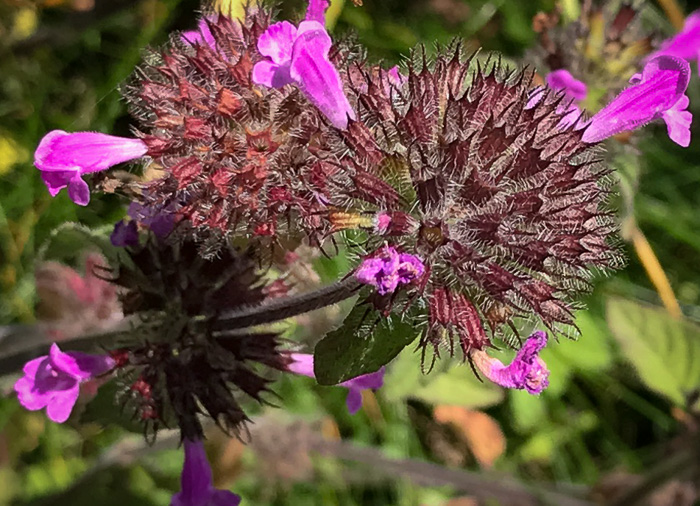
[{"x1": 314, "y1": 304, "x2": 418, "y2": 385}]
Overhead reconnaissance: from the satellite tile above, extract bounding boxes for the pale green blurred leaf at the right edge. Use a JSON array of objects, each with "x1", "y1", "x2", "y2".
[{"x1": 607, "y1": 298, "x2": 700, "y2": 406}]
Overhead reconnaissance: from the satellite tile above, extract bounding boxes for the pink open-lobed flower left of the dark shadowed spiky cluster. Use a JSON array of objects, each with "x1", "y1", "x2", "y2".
[{"x1": 15, "y1": 343, "x2": 115, "y2": 423}]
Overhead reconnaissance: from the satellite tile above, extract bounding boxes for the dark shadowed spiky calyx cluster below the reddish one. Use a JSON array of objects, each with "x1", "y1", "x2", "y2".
[{"x1": 105, "y1": 239, "x2": 289, "y2": 439}]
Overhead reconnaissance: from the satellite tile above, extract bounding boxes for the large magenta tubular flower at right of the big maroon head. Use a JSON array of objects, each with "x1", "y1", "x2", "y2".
[{"x1": 582, "y1": 56, "x2": 693, "y2": 147}]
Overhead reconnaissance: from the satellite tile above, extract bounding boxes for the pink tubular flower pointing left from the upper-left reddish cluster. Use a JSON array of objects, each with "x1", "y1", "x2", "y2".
[{"x1": 34, "y1": 130, "x2": 148, "y2": 206}]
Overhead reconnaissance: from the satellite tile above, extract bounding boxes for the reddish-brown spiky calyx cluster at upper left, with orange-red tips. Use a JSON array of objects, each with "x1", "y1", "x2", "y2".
[{"x1": 126, "y1": 8, "x2": 358, "y2": 254}]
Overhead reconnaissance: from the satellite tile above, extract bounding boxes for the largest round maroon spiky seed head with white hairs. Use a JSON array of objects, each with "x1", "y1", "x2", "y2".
[{"x1": 320, "y1": 47, "x2": 622, "y2": 354}]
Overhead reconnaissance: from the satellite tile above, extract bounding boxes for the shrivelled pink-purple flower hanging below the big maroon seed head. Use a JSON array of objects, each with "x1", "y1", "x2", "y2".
[{"x1": 471, "y1": 330, "x2": 549, "y2": 395}]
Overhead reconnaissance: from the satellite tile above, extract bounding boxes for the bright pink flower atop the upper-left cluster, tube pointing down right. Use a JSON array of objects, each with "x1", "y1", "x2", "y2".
[{"x1": 253, "y1": 0, "x2": 355, "y2": 129}]
